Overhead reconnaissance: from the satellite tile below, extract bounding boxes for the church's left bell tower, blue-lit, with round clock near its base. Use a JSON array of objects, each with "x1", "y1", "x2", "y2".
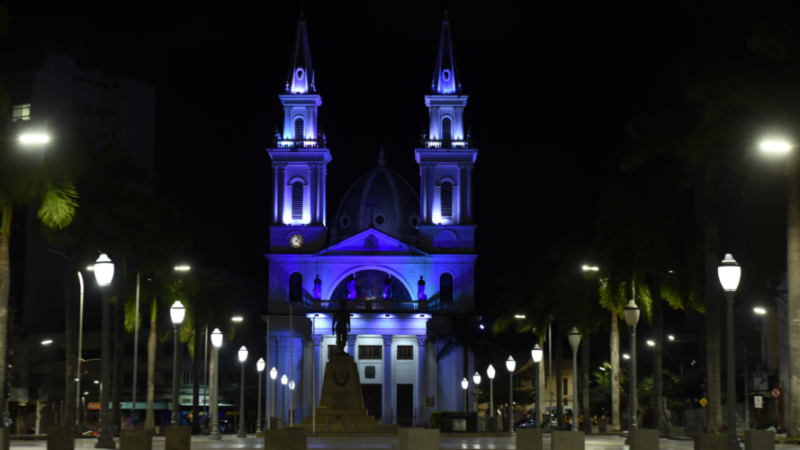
[{"x1": 267, "y1": 12, "x2": 331, "y2": 253}]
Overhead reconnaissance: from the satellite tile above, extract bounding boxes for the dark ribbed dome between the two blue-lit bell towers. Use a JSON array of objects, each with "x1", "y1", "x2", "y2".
[{"x1": 331, "y1": 150, "x2": 419, "y2": 245}]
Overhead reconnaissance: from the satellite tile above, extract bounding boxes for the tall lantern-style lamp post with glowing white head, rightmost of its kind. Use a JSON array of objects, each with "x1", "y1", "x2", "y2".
[{"x1": 717, "y1": 253, "x2": 746, "y2": 450}]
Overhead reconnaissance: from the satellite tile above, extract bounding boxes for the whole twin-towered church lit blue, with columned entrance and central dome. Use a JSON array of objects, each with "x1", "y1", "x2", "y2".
[{"x1": 263, "y1": 13, "x2": 478, "y2": 426}]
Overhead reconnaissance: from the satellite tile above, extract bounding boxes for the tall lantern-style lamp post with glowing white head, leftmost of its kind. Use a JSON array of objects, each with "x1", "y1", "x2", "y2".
[{"x1": 94, "y1": 253, "x2": 116, "y2": 448}]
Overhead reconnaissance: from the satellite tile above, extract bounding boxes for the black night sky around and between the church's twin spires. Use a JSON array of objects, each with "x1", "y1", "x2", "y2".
[{"x1": 6, "y1": 0, "x2": 797, "y2": 316}]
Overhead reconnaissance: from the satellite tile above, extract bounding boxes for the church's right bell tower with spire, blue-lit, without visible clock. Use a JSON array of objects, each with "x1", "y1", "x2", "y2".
[{"x1": 415, "y1": 11, "x2": 478, "y2": 253}]
